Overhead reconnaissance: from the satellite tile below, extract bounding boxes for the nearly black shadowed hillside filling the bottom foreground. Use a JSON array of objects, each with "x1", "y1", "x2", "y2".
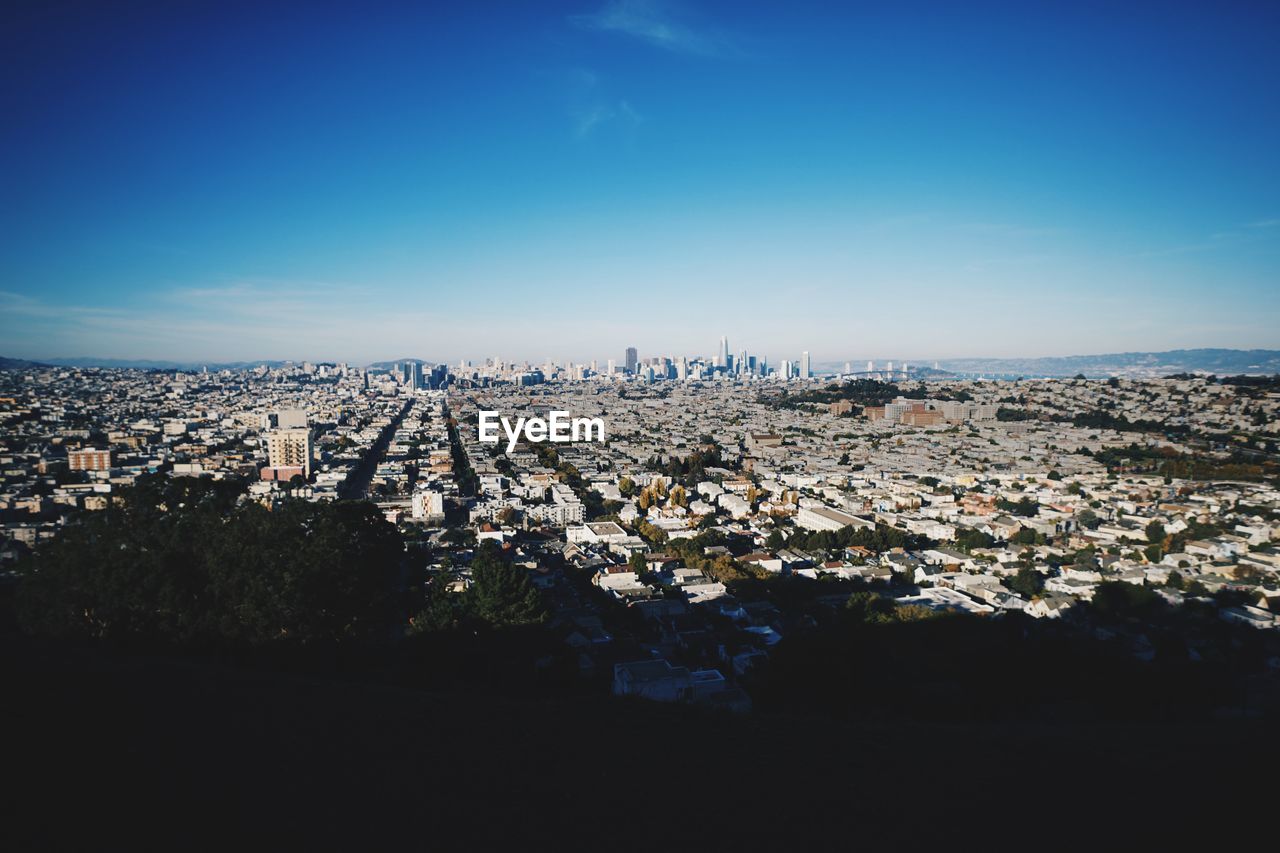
[{"x1": 0, "y1": 640, "x2": 1277, "y2": 850}]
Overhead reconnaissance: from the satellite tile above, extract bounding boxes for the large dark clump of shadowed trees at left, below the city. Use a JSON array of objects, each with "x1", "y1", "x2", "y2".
[{"x1": 18, "y1": 489, "x2": 404, "y2": 646}]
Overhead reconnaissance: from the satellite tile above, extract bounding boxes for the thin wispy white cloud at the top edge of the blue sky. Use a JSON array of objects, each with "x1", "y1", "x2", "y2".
[{"x1": 570, "y1": 0, "x2": 741, "y2": 56}]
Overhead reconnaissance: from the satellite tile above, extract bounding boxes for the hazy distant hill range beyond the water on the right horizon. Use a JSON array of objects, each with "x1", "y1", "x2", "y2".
[{"x1": 938, "y1": 350, "x2": 1280, "y2": 378}]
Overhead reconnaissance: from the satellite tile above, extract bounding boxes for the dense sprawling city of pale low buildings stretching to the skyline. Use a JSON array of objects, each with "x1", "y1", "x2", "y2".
[{"x1": 0, "y1": 360, "x2": 1280, "y2": 712}]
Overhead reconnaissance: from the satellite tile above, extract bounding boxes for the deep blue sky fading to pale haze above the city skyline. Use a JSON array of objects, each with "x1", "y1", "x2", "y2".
[{"x1": 0, "y1": 0, "x2": 1280, "y2": 364}]
